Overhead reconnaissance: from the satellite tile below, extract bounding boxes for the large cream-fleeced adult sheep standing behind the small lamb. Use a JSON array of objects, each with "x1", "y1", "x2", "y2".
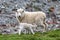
[{"x1": 16, "y1": 8, "x2": 47, "y2": 32}]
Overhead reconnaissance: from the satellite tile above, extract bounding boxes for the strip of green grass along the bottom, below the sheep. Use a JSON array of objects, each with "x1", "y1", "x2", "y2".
[{"x1": 0, "y1": 29, "x2": 60, "y2": 40}]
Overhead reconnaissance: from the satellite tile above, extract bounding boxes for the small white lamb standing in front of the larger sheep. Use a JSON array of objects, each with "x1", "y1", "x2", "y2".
[{"x1": 18, "y1": 23, "x2": 37, "y2": 35}]
